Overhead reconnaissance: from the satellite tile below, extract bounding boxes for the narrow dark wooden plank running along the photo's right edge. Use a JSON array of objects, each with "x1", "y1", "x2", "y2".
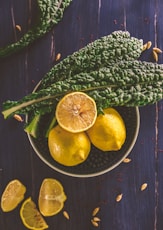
[{"x1": 155, "y1": 1, "x2": 163, "y2": 229}]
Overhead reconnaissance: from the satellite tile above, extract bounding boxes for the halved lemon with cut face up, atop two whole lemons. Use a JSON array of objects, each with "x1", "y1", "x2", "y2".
[{"x1": 56, "y1": 92, "x2": 97, "y2": 133}]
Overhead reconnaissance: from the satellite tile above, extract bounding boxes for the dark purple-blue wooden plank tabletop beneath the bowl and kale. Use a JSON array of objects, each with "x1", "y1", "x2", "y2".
[{"x1": 0, "y1": 0, "x2": 163, "y2": 230}]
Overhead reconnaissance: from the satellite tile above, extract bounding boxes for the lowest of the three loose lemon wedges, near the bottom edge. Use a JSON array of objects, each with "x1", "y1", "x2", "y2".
[{"x1": 20, "y1": 197, "x2": 48, "y2": 230}]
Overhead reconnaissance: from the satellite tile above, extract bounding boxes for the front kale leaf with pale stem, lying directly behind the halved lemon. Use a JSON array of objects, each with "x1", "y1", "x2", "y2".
[{"x1": 2, "y1": 61, "x2": 163, "y2": 118}]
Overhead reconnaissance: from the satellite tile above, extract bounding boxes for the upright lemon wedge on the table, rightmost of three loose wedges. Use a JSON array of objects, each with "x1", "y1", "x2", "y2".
[{"x1": 38, "y1": 178, "x2": 67, "y2": 216}]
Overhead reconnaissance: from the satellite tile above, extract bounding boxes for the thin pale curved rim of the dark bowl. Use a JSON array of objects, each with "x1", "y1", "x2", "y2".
[{"x1": 26, "y1": 107, "x2": 140, "y2": 178}]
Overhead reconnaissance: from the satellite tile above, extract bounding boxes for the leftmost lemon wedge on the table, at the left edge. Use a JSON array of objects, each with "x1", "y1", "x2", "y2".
[{"x1": 1, "y1": 179, "x2": 26, "y2": 212}]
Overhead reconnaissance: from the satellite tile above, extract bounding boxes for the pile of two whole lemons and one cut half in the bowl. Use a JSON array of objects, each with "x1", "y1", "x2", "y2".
[{"x1": 48, "y1": 92, "x2": 126, "y2": 166}]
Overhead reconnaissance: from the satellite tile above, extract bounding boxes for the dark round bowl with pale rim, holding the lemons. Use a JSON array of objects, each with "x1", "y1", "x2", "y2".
[{"x1": 27, "y1": 107, "x2": 139, "y2": 177}]
